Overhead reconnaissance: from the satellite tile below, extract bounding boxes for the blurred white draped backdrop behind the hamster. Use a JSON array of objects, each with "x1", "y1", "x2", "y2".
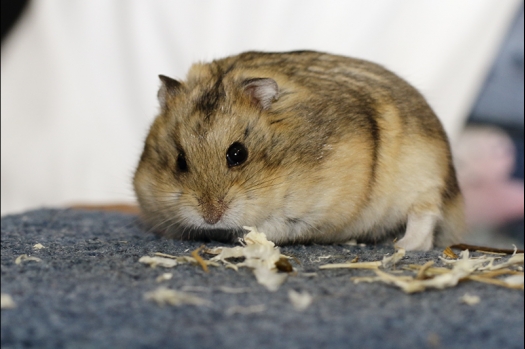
[{"x1": 1, "y1": 0, "x2": 521, "y2": 214}]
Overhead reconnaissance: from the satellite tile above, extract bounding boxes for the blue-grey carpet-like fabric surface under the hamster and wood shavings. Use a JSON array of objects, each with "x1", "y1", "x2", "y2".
[{"x1": 1, "y1": 210, "x2": 524, "y2": 349}]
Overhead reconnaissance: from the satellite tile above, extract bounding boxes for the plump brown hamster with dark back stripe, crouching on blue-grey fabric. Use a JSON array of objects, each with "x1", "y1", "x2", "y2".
[{"x1": 133, "y1": 51, "x2": 464, "y2": 250}]
